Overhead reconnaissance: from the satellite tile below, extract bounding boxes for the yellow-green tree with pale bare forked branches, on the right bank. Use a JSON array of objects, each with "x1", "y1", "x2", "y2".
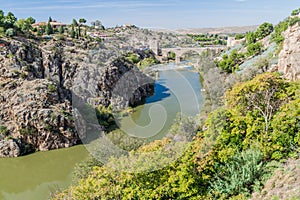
[{"x1": 225, "y1": 73, "x2": 288, "y2": 132}]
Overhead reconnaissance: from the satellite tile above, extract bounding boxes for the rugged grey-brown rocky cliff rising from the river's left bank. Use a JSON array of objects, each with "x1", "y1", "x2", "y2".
[{"x1": 0, "y1": 38, "x2": 153, "y2": 157}]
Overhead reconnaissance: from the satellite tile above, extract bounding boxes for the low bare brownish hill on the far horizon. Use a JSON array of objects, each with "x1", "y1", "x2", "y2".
[{"x1": 154, "y1": 25, "x2": 258, "y2": 34}]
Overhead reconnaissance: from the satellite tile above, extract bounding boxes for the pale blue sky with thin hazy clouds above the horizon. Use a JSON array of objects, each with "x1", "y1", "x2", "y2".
[{"x1": 0, "y1": 0, "x2": 300, "y2": 29}]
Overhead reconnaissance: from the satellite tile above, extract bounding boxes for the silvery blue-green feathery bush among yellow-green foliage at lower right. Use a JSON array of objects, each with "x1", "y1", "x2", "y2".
[{"x1": 209, "y1": 149, "x2": 273, "y2": 199}]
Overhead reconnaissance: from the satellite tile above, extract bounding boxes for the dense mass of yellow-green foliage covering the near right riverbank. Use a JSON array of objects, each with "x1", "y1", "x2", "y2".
[{"x1": 55, "y1": 73, "x2": 300, "y2": 200}]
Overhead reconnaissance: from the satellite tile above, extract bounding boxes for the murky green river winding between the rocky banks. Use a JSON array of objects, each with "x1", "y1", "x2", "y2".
[{"x1": 0, "y1": 64, "x2": 203, "y2": 200}]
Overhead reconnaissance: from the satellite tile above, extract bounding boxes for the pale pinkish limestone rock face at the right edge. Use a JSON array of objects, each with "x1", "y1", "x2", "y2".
[{"x1": 278, "y1": 23, "x2": 300, "y2": 81}]
